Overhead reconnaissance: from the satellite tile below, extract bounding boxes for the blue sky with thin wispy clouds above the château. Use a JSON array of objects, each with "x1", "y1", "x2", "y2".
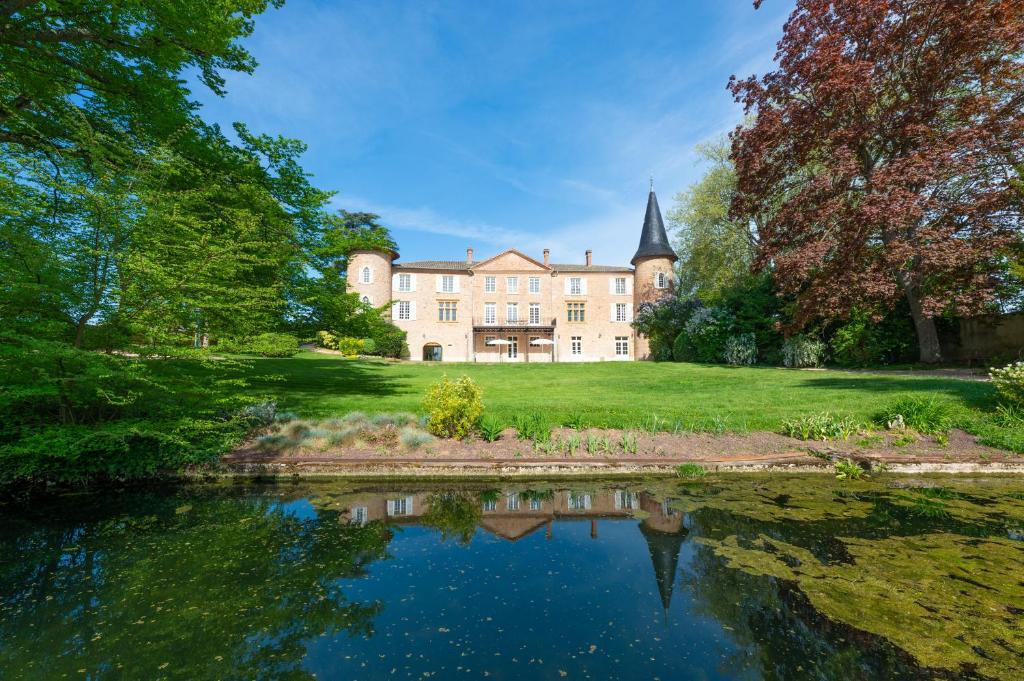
[{"x1": 197, "y1": 0, "x2": 792, "y2": 264}]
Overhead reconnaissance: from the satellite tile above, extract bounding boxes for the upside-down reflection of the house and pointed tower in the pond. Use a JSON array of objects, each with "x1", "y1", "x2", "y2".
[{"x1": 342, "y1": 490, "x2": 686, "y2": 610}]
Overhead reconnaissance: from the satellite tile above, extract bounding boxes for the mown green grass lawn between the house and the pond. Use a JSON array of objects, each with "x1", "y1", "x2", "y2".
[{"x1": 228, "y1": 352, "x2": 1018, "y2": 449}]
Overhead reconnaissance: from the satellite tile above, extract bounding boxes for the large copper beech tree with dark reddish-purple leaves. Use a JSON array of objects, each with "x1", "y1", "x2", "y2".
[{"x1": 729, "y1": 0, "x2": 1024, "y2": 361}]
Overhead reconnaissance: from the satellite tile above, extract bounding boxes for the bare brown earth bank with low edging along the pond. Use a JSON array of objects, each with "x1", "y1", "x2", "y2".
[{"x1": 217, "y1": 430, "x2": 1024, "y2": 478}]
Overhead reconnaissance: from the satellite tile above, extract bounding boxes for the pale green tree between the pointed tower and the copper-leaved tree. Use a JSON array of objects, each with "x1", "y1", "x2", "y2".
[{"x1": 669, "y1": 137, "x2": 758, "y2": 303}]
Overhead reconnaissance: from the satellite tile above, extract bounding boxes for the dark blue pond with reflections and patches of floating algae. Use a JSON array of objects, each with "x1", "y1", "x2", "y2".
[{"x1": 0, "y1": 475, "x2": 1024, "y2": 680}]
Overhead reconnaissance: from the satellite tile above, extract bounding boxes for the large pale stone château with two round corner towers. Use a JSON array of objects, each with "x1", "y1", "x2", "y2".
[{"x1": 347, "y1": 190, "x2": 677, "y2": 363}]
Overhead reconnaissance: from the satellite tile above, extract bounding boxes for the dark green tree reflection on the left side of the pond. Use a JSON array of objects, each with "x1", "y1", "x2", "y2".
[{"x1": 0, "y1": 495, "x2": 391, "y2": 679}]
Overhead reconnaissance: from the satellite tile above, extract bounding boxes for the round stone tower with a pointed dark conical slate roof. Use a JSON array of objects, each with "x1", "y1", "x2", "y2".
[{"x1": 630, "y1": 183, "x2": 679, "y2": 359}]
